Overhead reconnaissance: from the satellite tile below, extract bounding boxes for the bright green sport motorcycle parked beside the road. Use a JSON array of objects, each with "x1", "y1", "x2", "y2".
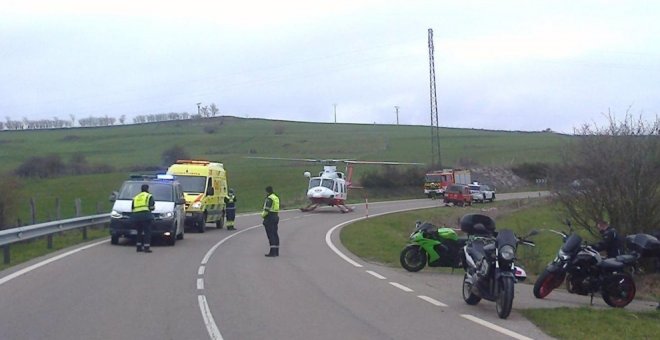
[{"x1": 399, "y1": 221, "x2": 465, "y2": 272}]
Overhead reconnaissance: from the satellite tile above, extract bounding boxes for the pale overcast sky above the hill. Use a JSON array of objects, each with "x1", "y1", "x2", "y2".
[{"x1": 0, "y1": 0, "x2": 660, "y2": 133}]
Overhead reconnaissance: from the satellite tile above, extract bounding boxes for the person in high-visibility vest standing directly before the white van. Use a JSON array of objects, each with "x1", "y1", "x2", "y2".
[{"x1": 131, "y1": 184, "x2": 156, "y2": 253}]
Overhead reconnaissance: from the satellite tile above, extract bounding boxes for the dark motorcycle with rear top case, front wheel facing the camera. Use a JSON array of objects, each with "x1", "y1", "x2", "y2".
[{"x1": 460, "y1": 214, "x2": 538, "y2": 319}]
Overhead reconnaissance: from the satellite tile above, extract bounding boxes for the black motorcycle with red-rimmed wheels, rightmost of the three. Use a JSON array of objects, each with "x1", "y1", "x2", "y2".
[{"x1": 533, "y1": 223, "x2": 660, "y2": 308}]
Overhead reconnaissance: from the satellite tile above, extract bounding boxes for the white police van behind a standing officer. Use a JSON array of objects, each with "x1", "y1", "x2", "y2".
[{"x1": 110, "y1": 175, "x2": 186, "y2": 246}]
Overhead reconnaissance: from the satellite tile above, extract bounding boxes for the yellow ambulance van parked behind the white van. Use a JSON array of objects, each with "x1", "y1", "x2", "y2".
[{"x1": 167, "y1": 160, "x2": 228, "y2": 233}]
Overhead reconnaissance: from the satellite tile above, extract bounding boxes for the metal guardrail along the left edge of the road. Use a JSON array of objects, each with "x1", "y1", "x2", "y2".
[{"x1": 0, "y1": 213, "x2": 110, "y2": 264}]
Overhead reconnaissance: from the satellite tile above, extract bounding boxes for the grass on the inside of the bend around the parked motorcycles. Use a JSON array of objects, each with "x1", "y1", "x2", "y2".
[{"x1": 340, "y1": 199, "x2": 660, "y2": 339}]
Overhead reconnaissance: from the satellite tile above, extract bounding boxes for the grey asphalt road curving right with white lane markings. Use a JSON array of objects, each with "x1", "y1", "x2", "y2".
[{"x1": 0, "y1": 195, "x2": 656, "y2": 339}]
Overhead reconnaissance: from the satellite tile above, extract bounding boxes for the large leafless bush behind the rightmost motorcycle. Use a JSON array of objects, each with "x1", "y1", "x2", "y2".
[{"x1": 552, "y1": 112, "x2": 660, "y2": 234}]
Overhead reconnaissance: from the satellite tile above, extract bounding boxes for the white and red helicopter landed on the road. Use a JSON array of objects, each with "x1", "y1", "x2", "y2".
[{"x1": 249, "y1": 157, "x2": 422, "y2": 213}]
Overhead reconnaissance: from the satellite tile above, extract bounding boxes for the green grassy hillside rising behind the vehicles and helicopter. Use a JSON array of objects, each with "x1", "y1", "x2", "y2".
[{"x1": 0, "y1": 117, "x2": 571, "y2": 223}]
